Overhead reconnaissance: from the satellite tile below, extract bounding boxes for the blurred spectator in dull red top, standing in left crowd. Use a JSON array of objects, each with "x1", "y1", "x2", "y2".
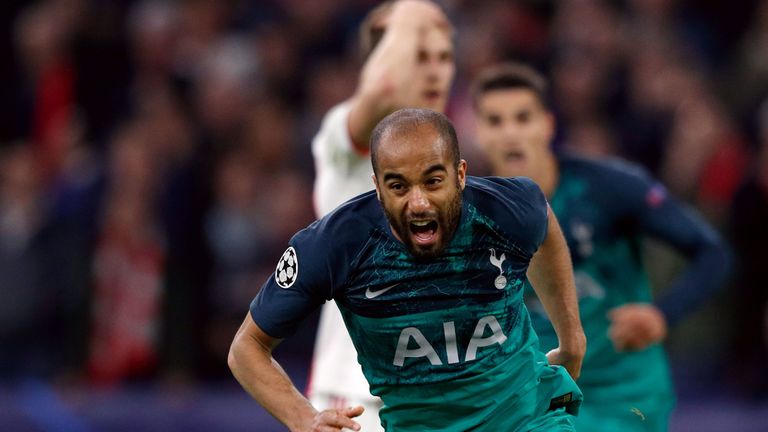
[{"x1": 88, "y1": 124, "x2": 166, "y2": 384}]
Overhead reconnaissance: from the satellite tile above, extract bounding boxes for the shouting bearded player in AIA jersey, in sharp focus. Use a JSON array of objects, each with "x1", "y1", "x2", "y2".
[{"x1": 229, "y1": 109, "x2": 586, "y2": 431}]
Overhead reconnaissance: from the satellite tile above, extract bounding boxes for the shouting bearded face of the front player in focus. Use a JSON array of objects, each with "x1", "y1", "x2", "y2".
[{"x1": 374, "y1": 125, "x2": 467, "y2": 259}]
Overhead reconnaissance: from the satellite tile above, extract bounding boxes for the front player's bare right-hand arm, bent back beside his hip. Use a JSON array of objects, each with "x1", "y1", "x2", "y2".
[{"x1": 528, "y1": 205, "x2": 587, "y2": 379}]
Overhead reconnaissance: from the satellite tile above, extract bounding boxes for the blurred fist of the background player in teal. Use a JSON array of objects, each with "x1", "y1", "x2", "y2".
[{"x1": 608, "y1": 303, "x2": 667, "y2": 351}]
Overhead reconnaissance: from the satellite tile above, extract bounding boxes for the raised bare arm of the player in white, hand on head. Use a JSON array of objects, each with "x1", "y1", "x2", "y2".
[{"x1": 348, "y1": 0, "x2": 449, "y2": 147}]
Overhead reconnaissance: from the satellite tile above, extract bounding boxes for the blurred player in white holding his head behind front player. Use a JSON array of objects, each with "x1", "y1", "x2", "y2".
[{"x1": 307, "y1": 0, "x2": 455, "y2": 431}]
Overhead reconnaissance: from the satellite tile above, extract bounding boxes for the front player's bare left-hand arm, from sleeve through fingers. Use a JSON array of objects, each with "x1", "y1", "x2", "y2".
[{"x1": 227, "y1": 313, "x2": 363, "y2": 431}]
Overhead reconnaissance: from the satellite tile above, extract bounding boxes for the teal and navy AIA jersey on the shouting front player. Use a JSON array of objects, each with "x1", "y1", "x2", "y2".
[{"x1": 251, "y1": 177, "x2": 580, "y2": 431}]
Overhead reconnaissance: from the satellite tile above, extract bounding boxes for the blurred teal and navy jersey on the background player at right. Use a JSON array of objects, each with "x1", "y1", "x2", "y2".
[{"x1": 526, "y1": 156, "x2": 707, "y2": 431}]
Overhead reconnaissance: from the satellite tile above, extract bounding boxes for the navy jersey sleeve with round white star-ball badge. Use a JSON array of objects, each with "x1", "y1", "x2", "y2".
[{"x1": 250, "y1": 220, "x2": 344, "y2": 338}]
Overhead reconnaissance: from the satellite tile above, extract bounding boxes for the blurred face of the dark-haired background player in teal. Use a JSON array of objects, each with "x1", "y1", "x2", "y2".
[{"x1": 475, "y1": 88, "x2": 554, "y2": 177}]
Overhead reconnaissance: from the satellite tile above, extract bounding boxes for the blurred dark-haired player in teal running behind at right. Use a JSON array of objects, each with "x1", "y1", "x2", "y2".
[{"x1": 473, "y1": 64, "x2": 730, "y2": 432}]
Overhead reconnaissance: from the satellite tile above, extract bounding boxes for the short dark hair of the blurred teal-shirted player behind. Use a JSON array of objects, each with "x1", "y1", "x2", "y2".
[{"x1": 470, "y1": 62, "x2": 551, "y2": 109}]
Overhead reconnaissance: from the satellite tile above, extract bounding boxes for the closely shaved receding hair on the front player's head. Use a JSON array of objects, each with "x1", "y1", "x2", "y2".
[{"x1": 369, "y1": 108, "x2": 461, "y2": 175}]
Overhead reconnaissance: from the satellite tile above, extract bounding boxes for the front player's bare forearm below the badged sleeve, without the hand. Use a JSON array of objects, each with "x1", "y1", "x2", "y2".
[{"x1": 228, "y1": 316, "x2": 317, "y2": 431}]
